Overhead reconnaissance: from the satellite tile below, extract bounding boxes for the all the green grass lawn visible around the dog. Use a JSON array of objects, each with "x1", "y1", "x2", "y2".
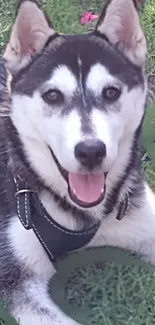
[{"x1": 0, "y1": 0, "x2": 155, "y2": 325}]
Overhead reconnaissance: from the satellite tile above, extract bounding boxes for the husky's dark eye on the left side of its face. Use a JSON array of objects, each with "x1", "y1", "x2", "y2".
[{"x1": 42, "y1": 89, "x2": 64, "y2": 105}]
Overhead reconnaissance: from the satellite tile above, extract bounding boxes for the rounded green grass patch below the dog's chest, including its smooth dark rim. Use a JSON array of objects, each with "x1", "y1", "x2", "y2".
[{"x1": 50, "y1": 247, "x2": 155, "y2": 325}]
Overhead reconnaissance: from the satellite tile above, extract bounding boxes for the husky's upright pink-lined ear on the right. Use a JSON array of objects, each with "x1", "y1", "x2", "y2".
[{"x1": 95, "y1": 0, "x2": 147, "y2": 67}]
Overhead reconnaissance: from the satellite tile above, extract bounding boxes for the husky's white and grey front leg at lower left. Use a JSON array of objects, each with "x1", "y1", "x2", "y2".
[{"x1": 6, "y1": 216, "x2": 80, "y2": 325}]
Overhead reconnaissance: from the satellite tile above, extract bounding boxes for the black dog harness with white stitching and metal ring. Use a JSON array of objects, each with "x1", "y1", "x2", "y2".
[{"x1": 14, "y1": 177, "x2": 129, "y2": 262}]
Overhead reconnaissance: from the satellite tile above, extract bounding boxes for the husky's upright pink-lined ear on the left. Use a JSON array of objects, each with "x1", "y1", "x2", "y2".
[{"x1": 4, "y1": 0, "x2": 56, "y2": 74}]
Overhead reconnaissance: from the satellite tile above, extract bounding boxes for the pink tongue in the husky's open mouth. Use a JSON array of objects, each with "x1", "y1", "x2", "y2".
[{"x1": 68, "y1": 173, "x2": 105, "y2": 203}]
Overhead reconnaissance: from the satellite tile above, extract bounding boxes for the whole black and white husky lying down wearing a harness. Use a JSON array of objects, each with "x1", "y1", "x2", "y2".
[{"x1": 0, "y1": 0, "x2": 155, "y2": 325}]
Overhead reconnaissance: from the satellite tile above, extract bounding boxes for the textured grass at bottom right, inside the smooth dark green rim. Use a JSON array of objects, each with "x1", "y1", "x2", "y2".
[{"x1": 66, "y1": 262, "x2": 155, "y2": 325}]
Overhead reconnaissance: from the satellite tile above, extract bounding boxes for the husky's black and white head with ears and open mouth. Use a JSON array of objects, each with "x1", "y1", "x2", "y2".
[{"x1": 4, "y1": 0, "x2": 146, "y2": 208}]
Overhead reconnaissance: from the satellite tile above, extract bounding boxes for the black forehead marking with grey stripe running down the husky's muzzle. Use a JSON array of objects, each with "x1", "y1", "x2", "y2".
[{"x1": 12, "y1": 34, "x2": 144, "y2": 134}]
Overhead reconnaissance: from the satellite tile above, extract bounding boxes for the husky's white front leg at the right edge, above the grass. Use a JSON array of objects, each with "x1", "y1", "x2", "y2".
[{"x1": 89, "y1": 185, "x2": 155, "y2": 264}]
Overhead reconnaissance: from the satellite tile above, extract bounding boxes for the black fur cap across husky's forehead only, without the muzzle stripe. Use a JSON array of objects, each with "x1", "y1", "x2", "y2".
[{"x1": 12, "y1": 35, "x2": 143, "y2": 96}]
